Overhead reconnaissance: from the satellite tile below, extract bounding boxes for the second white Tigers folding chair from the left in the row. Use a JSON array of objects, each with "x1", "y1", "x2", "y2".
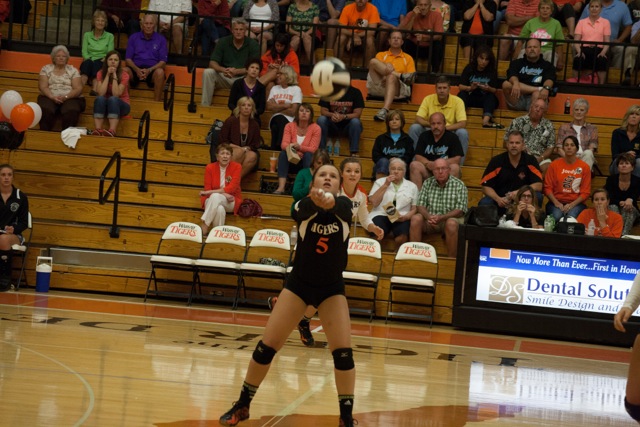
[{"x1": 195, "y1": 225, "x2": 247, "y2": 302}]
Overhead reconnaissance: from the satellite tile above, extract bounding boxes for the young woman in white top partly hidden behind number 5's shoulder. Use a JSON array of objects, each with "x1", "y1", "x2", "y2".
[{"x1": 340, "y1": 157, "x2": 384, "y2": 240}]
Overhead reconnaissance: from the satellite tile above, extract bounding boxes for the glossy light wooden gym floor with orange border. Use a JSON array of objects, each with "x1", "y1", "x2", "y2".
[{"x1": 0, "y1": 289, "x2": 637, "y2": 427}]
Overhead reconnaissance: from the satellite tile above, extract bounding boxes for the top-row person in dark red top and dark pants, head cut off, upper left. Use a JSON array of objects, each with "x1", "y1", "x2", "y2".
[{"x1": 198, "y1": 0, "x2": 231, "y2": 57}]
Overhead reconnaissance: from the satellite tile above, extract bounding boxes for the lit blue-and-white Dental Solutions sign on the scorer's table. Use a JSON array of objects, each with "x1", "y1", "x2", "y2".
[{"x1": 476, "y1": 247, "x2": 640, "y2": 316}]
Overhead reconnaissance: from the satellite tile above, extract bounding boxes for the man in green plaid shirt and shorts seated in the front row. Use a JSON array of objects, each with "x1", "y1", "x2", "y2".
[{"x1": 409, "y1": 159, "x2": 469, "y2": 257}]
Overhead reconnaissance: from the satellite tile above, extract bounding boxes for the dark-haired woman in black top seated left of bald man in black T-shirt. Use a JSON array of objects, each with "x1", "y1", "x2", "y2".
[{"x1": 371, "y1": 110, "x2": 413, "y2": 179}]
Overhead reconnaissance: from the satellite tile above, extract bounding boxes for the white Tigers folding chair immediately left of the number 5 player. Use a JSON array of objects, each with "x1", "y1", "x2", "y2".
[{"x1": 233, "y1": 228, "x2": 291, "y2": 309}]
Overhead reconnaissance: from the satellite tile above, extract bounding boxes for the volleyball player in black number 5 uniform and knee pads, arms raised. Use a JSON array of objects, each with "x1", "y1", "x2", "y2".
[{"x1": 220, "y1": 165, "x2": 356, "y2": 427}]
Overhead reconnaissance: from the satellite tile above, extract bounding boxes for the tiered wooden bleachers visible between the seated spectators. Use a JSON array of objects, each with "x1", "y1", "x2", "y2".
[{"x1": 0, "y1": 52, "x2": 632, "y2": 323}]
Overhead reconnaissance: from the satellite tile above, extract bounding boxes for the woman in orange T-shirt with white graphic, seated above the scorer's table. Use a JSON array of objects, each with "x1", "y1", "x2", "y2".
[{"x1": 544, "y1": 135, "x2": 591, "y2": 222}]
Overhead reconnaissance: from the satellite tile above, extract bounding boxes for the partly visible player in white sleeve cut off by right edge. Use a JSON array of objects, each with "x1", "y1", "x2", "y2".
[{"x1": 613, "y1": 273, "x2": 640, "y2": 423}]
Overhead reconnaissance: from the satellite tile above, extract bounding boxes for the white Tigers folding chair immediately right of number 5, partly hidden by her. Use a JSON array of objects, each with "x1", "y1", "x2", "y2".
[{"x1": 342, "y1": 237, "x2": 382, "y2": 322}]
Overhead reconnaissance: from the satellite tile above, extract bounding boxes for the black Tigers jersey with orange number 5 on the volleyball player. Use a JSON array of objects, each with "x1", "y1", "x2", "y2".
[{"x1": 291, "y1": 196, "x2": 352, "y2": 287}]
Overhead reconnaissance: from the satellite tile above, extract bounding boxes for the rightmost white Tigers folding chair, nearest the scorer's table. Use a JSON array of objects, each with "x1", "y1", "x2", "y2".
[{"x1": 385, "y1": 242, "x2": 438, "y2": 327}]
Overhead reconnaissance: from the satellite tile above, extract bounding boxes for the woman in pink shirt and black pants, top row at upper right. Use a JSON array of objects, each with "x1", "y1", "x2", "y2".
[{"x1": 573, "y1": 0, "x2": 611, "y2": 84}]
